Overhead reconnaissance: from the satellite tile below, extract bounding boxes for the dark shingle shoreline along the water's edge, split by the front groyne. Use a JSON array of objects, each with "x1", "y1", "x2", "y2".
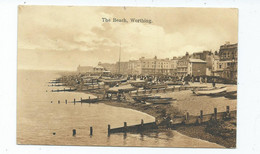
[{"x1": 55, "y1": 74, "x2": 236, "y2": 148}]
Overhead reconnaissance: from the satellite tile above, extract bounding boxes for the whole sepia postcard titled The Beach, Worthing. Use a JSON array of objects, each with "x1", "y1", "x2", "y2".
[{"x1": 16, "y1": 5, "x2": 238, "y2": 148}]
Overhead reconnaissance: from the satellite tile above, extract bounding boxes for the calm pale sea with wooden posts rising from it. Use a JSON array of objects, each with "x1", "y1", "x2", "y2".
[{"x1": 17, "y1": 70, "x2": 221, "y2": 147}]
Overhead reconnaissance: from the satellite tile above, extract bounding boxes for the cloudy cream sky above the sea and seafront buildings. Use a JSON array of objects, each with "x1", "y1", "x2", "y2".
[{"x1": 18, "y1": 6, "x2": 238, "y2": 70}]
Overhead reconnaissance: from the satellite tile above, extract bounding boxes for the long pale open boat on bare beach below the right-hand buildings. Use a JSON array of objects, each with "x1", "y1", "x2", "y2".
[{"x1": 193, "y1": 87, "x2": 227, "y2": 96}]
